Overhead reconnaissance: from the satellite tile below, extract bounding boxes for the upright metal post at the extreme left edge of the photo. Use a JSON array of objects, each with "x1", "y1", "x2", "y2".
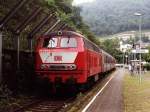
[{"x1": 0, "y1": 31, "x2": 3, "y2": 83}]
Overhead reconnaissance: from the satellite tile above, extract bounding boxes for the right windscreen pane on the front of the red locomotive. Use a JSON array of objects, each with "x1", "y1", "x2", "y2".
[{"x1": 60, "y1": 37, "x2": 77, "y2": 47}]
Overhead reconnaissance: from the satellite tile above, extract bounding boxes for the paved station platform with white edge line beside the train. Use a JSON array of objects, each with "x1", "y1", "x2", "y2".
[{"x1": 82, "y1": 68, "x2": 125, "y2": 112}]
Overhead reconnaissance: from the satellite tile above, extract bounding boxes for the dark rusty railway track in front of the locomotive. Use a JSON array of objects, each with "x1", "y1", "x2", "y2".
[{"x1": 13, "y1": 97, "x2": 75, "y2": 112}]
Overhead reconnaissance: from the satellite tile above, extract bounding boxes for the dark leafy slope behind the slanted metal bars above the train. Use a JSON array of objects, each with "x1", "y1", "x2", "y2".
[{"x1": 0, "y1": 0, "x2": 99, "y2": 50}]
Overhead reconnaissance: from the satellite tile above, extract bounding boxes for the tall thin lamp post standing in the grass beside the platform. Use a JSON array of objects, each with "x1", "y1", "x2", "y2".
[{"x1": 134, "y1": 12, "x2": 142, "y2": 84}]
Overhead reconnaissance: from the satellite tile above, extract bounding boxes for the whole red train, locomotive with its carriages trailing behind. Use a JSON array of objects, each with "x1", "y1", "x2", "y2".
[{"x1": 36, "y1": 31, "x2": 116, "y2": 84}]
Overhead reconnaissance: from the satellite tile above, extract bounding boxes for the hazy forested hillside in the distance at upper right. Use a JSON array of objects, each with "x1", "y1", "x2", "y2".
[{"x1": 79, "y1": 0, "x2": 150, "y2": 35}]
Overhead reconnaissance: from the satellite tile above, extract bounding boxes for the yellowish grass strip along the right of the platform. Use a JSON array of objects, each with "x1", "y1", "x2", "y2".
[{"x1": 123, "y1": 72, "x2": 150, "y2": 112}]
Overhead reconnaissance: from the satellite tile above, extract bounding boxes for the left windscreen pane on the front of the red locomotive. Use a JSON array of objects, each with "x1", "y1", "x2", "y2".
[{"x1": 43, "y1": 38, "x2": 58, "y2": 48}]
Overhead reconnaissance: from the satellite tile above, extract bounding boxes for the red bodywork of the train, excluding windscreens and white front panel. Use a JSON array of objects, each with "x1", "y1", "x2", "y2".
[{"x1": 36, "y1": 31, "x2": 116, "y2": 83}]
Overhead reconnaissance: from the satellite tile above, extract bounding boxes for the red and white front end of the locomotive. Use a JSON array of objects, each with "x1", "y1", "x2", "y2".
[{"x1": 36, "y1": 32, "x2": 85, "y2": 82}]
